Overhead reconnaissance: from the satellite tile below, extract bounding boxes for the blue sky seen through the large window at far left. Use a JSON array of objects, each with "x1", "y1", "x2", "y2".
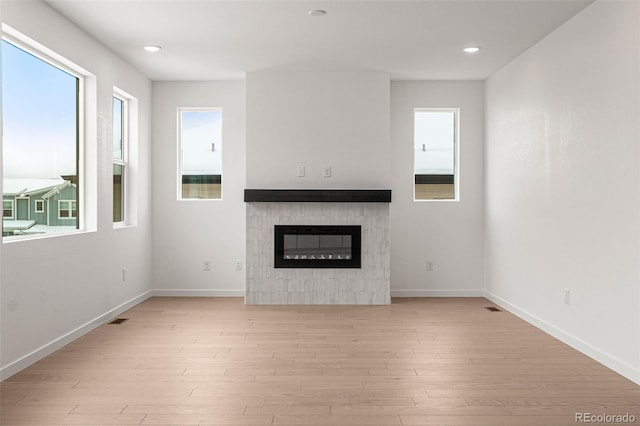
[{"x1": 2, "y1": 40, "x2": 78, "y2": 178}]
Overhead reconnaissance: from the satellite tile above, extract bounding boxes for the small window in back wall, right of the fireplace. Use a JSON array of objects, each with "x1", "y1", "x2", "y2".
[{"x1": 413, "y1": 108, "x2": 458, "y2": 200}]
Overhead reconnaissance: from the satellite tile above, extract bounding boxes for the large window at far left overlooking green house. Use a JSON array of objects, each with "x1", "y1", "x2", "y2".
[{"x1": 2, "y1": 37, "x2": 83, "y2": 239}]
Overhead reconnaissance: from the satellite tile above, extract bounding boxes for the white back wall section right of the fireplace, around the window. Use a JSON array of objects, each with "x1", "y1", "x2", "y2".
[{"x1": 390, "y1": 81, "x2": 484, "y2": 296}]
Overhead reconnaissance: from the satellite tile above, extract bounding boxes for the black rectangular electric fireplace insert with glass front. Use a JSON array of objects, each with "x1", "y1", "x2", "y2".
[{"x1": 273, "y1": 225, "x2": 361, "y2": 268}]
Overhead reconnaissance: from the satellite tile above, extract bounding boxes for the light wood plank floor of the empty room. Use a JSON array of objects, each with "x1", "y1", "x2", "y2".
[{"x1": 0, "y1": 298, "x2": 640, "y2": 426}]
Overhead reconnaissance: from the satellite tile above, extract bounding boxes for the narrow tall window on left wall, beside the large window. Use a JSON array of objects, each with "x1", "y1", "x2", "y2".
[{"x1": 113, "y1": 94, "x2": 128, "y2": 224}]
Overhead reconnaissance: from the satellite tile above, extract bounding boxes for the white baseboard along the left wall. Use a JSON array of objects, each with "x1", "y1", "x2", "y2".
[{"x1": 0, "y1": 290, "x2": 151, "y2": 381}]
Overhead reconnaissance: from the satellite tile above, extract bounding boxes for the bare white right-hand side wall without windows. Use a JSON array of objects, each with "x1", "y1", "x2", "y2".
[{"x1": 485, "y1": 1, "x2": 640, "y2": 382}]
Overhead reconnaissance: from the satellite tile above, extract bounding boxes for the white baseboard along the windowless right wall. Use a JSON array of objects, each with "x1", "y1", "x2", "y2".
[{"x1": 484, "y1": 291, "x2": 640, "y2": 384}]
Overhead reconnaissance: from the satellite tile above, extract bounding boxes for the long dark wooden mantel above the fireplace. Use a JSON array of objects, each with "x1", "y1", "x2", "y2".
[{"x1": 244, "y1": 189, "x2": 391, "y2": 203}]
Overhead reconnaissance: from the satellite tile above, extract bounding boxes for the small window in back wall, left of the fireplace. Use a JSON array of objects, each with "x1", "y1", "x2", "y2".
[{"x1": 178, "y1": 108, "x2": 222, "y2": 200}]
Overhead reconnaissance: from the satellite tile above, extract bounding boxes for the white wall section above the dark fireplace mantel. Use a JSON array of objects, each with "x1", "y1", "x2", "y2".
[{"x1": 247, "y1": 71, "x2": 390, "y2": 189}]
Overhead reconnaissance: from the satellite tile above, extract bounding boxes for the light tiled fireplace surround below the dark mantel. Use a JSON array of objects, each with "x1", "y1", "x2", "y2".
[{"x1": 245, "y1": 191, "x2": 391, "y2": 305}]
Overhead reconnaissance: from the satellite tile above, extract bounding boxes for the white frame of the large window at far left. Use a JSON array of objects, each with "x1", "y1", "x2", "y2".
[{"x1": 0, "y1": 23, "x2": 92, "y2": 244}]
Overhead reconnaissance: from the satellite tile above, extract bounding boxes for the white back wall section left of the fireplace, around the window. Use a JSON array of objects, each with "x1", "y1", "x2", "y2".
[{"x1": 153, "y1": 81, "x2": 246, "y2": 296}]
